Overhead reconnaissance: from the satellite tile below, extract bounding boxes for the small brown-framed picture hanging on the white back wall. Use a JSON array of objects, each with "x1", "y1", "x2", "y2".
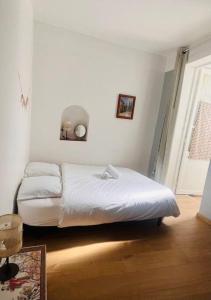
[{"x1": 116, "y1": 94, "x2": 136, "y2": 120}]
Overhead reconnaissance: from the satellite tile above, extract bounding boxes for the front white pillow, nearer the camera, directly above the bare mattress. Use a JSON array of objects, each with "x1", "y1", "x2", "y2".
[{"x1": 18, "y1": 176, "x2": 62, "y2": 200}]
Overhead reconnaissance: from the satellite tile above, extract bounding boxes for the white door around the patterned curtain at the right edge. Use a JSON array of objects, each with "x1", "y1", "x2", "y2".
[{"x1": 175, "y1": 64, "x2": 211, "y2": 196}]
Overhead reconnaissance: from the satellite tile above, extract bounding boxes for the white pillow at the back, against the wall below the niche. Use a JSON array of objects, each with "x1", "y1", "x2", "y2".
[{"x1": 24, "y1": 162, "x2": 61, "y2": 177}]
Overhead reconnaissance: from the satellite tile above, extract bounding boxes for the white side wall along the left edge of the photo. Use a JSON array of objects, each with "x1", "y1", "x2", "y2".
[{"x1": 0, "y1": 0, "x2": 33, "y2": 214}]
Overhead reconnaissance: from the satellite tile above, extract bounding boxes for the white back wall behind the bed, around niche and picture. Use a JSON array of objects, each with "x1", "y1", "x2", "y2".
[{"x1": 30, "y1": 23, "x2": 165, "y2": 173}]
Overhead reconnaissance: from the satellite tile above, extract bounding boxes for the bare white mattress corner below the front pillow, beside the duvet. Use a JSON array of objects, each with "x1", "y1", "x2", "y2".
[{"x1": 18, "y1": 198, "x2": 62, "y2": 226}]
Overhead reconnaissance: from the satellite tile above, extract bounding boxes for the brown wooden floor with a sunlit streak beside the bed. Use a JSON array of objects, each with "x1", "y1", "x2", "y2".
[{"x1": 24, "y1": 196, "x2": 211, "y2": 300}]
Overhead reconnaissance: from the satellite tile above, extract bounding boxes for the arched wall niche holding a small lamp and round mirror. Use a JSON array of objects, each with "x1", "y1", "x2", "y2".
[{"x1": 60, "y1": 105, "x2": 89, "y2": 141}]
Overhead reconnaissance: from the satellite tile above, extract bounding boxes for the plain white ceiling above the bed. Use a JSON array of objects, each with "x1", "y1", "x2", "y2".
[{"x1": 32, "y1": 0, "x2": 211, "y2": 53}]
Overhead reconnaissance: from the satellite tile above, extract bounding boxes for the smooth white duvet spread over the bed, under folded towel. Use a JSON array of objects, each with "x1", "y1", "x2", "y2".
[{"x1": 59, "y1": 163, "x2": 180, "y2": 227}]
